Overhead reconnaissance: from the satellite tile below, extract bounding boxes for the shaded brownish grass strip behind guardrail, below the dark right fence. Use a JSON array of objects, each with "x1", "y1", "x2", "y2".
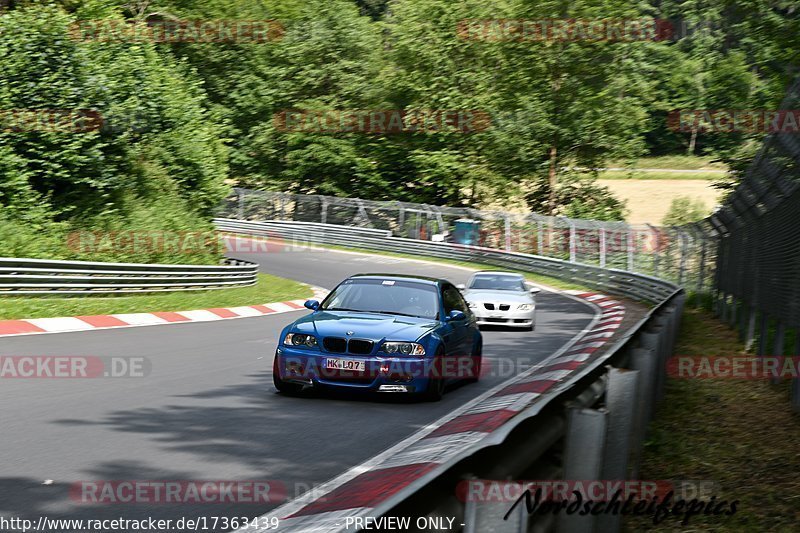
[{"x1": 625, "y1": 309, "x2": 800, "y2": 531}]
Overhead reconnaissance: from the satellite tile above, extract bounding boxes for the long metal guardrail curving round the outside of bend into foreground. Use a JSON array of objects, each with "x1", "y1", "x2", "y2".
[{"x1": 215, "y1": 219, "x2": 685, "y2": 533}]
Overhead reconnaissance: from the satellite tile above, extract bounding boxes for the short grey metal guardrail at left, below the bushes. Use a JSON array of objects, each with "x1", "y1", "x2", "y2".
[{"x1": 0, "y1": 257, "x2": 258, "y2": 296}]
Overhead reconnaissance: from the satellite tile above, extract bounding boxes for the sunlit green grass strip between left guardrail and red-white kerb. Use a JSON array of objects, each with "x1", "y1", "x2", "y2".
[{"x1": 0, "y1": 274, "x2": 311, "y2": 320}]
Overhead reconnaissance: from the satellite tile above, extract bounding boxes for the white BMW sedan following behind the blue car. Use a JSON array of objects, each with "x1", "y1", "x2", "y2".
[{"x1": 459, "y1": 272, "x2": 539, "y2": 330}]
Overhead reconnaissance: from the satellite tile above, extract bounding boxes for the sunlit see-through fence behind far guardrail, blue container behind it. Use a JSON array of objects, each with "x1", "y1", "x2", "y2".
[{"x1": 219, "y1": 189, "x2": 716, "y2": 292}]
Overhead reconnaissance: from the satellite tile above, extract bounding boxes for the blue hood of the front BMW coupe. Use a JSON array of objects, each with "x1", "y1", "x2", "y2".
[{"x1": 293, "y1": 311, "x2": 438, "y2": 342}]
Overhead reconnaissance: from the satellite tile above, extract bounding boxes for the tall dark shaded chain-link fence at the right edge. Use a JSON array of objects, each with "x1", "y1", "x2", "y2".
[{"x1": 709, "y1": 80, "x2": 800, "y2": 408}]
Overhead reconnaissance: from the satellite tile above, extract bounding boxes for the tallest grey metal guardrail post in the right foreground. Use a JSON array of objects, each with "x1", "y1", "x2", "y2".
[{"x1": 597, "y1": 368, "x2": 639, "y2": 533}]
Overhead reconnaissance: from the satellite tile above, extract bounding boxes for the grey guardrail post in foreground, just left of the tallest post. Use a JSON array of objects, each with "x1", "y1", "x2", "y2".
[{"x1": 558, "y1": 407, "x2": 608, "y2": 533}]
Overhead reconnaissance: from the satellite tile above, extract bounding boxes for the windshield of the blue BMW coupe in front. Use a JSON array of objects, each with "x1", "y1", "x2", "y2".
[{"x1": 321, "y1": 279, "x2": 439, "y2": 319}]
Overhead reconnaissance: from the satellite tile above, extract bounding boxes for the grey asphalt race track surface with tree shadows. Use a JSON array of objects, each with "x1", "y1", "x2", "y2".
[{"x1": 0, "y1": 246, "x2": 593, "y2": 531}]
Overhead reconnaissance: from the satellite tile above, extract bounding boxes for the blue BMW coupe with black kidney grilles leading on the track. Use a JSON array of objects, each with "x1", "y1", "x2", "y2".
[{"x1": 272, "y1": 274, "x2": 482, "y2": 401}]
